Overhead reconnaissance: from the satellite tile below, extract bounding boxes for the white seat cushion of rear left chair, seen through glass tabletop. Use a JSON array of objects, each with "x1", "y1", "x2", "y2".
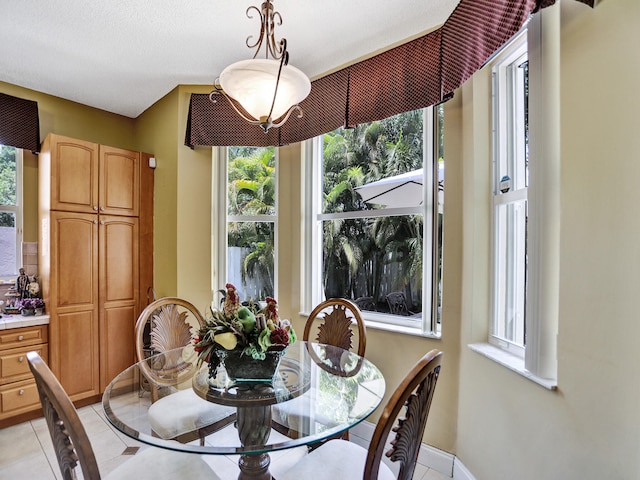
[{"x1": 149, "y1": 388, "x2": 235, "y2": 438}]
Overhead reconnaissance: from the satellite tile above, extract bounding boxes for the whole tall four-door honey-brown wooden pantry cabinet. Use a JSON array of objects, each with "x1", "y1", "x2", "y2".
[{"x1": 39, "y1": 135, "x2": 153, "y2": 401}]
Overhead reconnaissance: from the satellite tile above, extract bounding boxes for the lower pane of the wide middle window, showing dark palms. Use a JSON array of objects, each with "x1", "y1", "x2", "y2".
[{"x1": 322, "y1": 215, "x2": 423, "y2": 316}]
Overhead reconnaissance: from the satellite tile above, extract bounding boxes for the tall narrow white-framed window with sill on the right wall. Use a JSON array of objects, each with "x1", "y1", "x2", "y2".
[{"x1": 484, "y1": 14, "x2": 560, "y2": 389}]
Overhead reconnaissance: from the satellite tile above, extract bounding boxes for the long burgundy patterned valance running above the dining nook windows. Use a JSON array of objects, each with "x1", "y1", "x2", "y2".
[{"x1": 185, "y1": 0, "x2": 596, "y2": 148}]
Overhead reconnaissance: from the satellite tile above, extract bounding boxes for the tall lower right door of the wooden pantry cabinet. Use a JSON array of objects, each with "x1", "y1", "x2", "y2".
[{"x1": 99, "y1": 215, "x2": 139, "y2": 390}]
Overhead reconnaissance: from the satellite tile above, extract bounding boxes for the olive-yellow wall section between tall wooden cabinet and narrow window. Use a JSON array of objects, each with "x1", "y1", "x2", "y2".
[{"x1": 135, "y1": 86, "x2": 212, "y2": 311}]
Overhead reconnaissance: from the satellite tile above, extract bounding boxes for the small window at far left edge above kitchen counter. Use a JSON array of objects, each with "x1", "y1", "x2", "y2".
[{"x1": 0, "y1": 145, "x2": 22, "y2": 278}]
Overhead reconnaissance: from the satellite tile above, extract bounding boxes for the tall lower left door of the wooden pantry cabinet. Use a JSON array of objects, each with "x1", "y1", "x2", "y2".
[{"x1": 49, "y1": 212, "x2": 100, "y2": 400}]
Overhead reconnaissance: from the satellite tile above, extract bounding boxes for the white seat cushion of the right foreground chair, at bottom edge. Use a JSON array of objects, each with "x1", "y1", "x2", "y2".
[{"x1": 278, "y1": 440, "x2": 396, "y2": 480}]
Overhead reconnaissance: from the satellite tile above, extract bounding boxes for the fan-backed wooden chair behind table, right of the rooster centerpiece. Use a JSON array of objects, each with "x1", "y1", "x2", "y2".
[{"x1": 272, "y1": 298, "x2": 367, "y2": 442}]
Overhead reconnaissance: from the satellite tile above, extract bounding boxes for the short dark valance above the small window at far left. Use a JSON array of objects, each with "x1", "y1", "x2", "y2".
[{"x1": 0, "y1": 93, "x2": 40, "y2": 152}]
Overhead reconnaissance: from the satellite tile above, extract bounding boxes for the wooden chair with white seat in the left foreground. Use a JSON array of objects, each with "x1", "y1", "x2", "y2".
[{"x1": 27, "y1": 352, "x2": 220, "y2": 480}]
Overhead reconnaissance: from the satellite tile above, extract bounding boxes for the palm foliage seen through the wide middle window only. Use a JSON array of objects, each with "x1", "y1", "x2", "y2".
[{"x1": 323, "y1": 110, "x2": 423, "y2": 308}]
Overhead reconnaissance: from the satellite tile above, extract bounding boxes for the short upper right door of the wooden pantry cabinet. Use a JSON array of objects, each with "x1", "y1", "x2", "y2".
[{"x1": 99, "y1": 145, "x2": 140, "y2": 217}]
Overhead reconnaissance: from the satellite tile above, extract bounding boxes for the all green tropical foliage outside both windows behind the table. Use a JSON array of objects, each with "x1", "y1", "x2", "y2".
[{"x1": 228, "y1": 109, "x2": 443, "y2": 311}]
